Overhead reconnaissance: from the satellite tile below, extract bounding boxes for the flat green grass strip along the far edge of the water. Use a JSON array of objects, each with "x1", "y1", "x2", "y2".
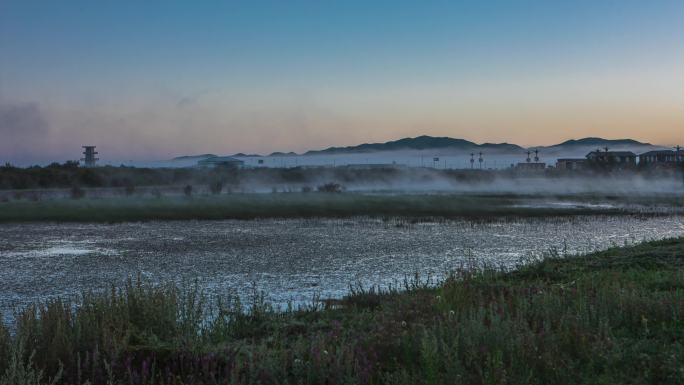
[{"x1": 0, "y1": 193, "x2": 644, "y2": 222}]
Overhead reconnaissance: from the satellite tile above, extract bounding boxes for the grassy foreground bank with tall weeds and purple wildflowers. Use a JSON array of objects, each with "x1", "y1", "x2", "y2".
[{"x1": 0, "y1": 238, "x2": 684, "y2": 385}]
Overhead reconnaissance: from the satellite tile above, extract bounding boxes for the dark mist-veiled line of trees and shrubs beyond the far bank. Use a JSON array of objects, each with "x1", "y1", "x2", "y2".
[{"x1": 0, "y1": 161, "x2": 684, "y2": 192}]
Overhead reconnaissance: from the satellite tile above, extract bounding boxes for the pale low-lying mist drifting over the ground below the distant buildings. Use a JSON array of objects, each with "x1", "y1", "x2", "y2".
[{"x1": 231, "y1": 167, "x2": 684, "y2": 194}]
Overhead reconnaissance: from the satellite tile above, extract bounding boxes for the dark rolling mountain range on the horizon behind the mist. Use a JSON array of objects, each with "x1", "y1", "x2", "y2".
[{"x1": 173, "y1": 135, "x2": 657, "y2": 160}]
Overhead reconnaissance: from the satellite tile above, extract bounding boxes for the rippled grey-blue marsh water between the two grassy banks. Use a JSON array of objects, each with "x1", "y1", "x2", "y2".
[{"x1": 0, "y1": 216, "x2": 684, "y2": 321}]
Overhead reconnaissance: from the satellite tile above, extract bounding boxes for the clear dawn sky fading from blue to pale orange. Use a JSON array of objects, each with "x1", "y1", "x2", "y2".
[{"x1": 0, "y1": 0, "x2": 684, "y2": 162}]
